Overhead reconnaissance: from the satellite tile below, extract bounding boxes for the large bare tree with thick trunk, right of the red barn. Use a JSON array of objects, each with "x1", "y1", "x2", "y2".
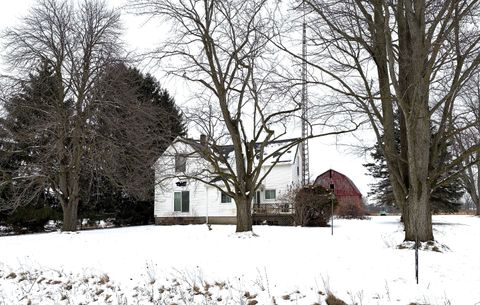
[{"x1": 296, "y1": 0, "x2": 480, "y2": 241}]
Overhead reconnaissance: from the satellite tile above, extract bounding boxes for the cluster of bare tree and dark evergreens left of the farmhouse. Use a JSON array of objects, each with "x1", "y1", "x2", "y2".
[{"x1": 0, "y1": 0, "x2": 185, "y2": 231}]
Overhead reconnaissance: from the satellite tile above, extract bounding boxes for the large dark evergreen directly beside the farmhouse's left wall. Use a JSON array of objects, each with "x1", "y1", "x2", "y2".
[{"x1": 79, "y1": 64, "x2": 186, "y2": 225}]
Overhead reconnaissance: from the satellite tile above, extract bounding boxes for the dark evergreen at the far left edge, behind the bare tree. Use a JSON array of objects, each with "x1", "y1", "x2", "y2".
[{"x1": 0, "y1": 61, "x2": 60, "y2": 232}]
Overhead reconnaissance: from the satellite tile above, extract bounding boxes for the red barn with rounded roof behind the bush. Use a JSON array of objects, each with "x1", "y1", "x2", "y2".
[{"x1": 313, "y1": 169, "x2": 362, "y2": 207}]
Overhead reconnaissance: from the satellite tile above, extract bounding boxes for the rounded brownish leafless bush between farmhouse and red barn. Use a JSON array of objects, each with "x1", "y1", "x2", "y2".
[{"x1": 295, "y1": 185, "x2": 337, "y2": 227}]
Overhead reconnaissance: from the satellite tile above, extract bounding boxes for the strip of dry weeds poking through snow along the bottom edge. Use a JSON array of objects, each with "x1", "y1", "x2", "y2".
[{"x1": 0, "y1": 270, "x2": 322, "y2": 305}]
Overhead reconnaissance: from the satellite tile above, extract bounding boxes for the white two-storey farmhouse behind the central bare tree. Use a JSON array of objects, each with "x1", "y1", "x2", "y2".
[{"x1": 154, "y1": 135, "x2": 302, "y2": 224}]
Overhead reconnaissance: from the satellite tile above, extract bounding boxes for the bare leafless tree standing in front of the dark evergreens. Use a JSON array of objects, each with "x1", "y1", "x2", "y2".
[{"x1": 3, "y1": 0, "x2": 148, "y2": 231}]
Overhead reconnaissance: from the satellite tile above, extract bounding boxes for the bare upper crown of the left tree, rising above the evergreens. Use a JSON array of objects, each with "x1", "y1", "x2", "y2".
[{"x1": 3, "y1": 0, "x2": 124, "y2": 100}]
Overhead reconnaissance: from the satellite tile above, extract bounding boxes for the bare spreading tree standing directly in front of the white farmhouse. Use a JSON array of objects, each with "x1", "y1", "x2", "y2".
[{"x1": 131, "y1": 0, "x2": 357, "y2": 232}]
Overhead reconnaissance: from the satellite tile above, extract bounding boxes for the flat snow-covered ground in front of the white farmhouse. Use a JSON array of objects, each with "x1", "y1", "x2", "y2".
[{"x1": 0, "y1": 216, "x2": 480, "y2": 305}]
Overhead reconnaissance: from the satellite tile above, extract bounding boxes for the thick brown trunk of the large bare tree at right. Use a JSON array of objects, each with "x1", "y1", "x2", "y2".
[{"x1": 396, "y1": 1, "x2": 433, "y2": 241}]
